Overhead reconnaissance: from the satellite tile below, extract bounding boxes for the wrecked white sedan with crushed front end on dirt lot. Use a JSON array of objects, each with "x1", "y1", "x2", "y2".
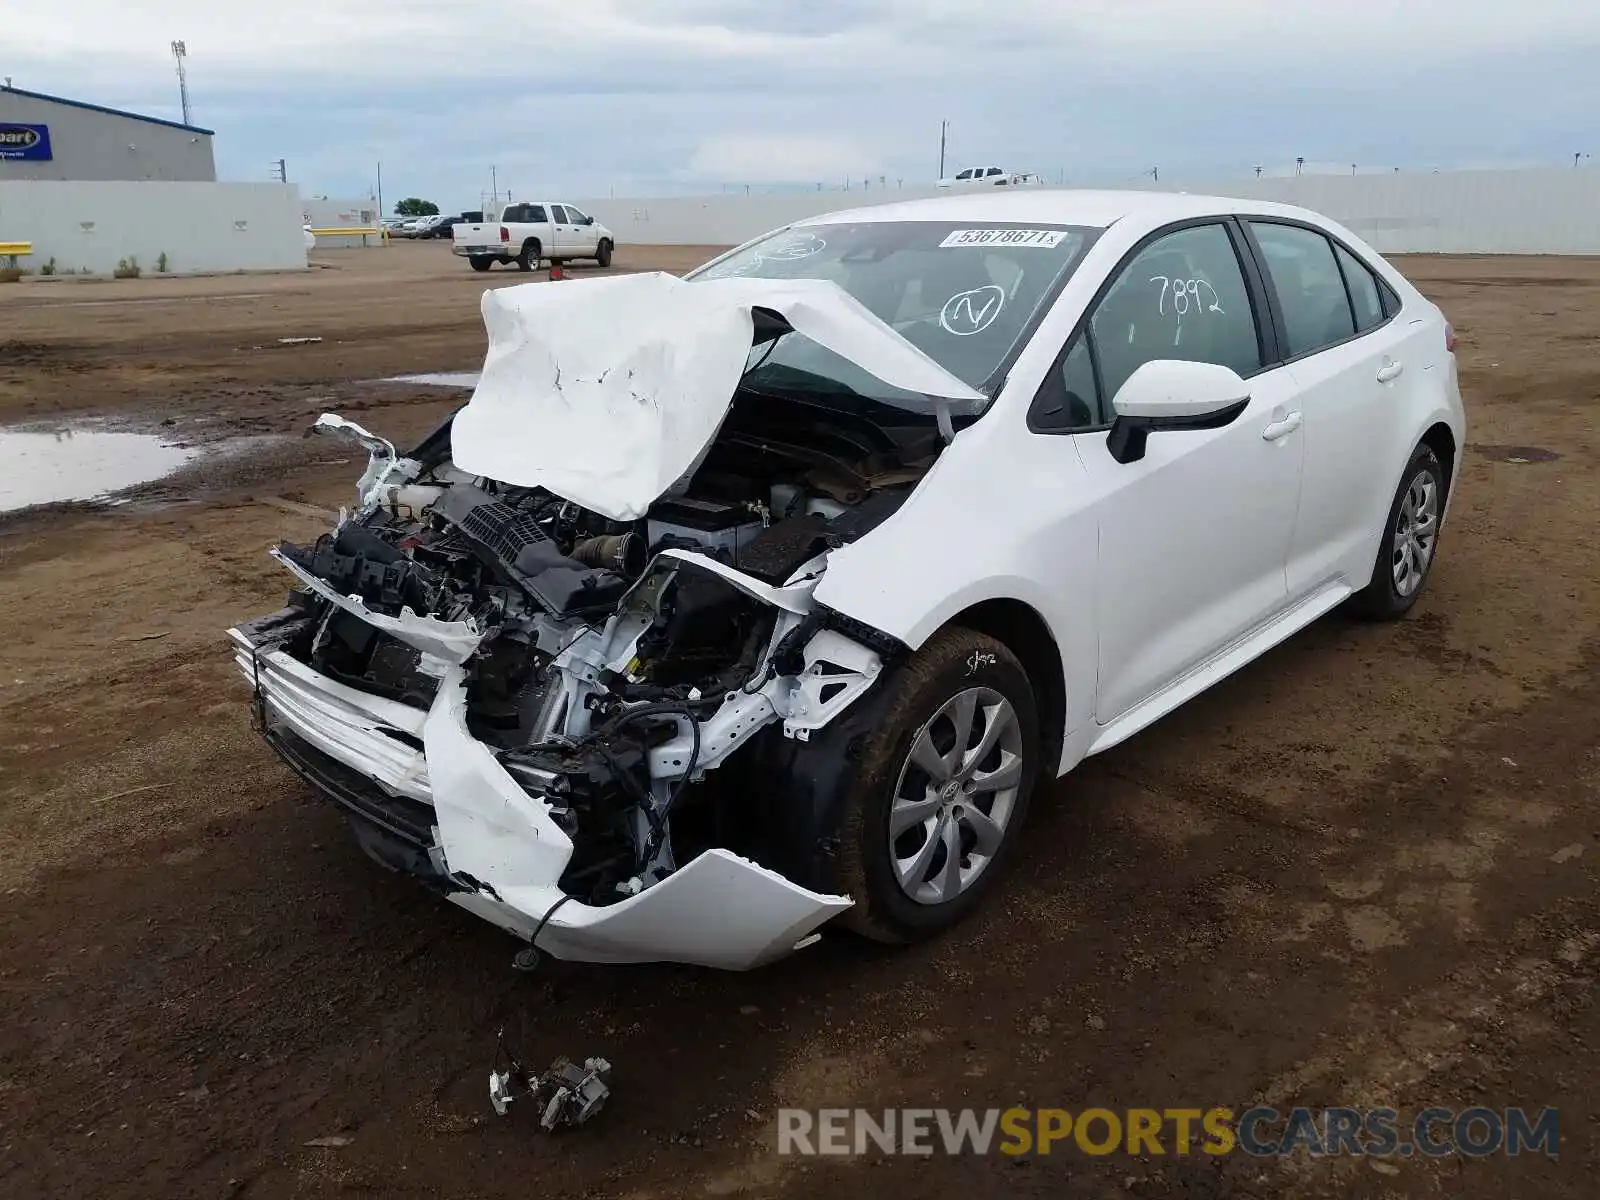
[{"x1": 230, "y1": 190, "x2": 1466, "y2": 968}]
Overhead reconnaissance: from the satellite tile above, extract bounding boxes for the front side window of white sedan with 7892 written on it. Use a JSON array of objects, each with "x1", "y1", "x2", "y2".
[{"x1": 1090, "y1": 226, "x2": 1260, "y2": 403}]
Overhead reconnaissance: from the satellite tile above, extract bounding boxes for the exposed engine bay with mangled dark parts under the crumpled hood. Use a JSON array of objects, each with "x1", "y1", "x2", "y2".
[{"x1": 258, "y1": 394, "x2": 942, "y2": 906}]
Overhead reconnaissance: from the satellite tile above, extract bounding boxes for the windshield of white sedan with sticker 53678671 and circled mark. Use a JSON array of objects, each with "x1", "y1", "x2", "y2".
[{"x1": 685, "y1": 221, "x2": 1099, "y2": 416}]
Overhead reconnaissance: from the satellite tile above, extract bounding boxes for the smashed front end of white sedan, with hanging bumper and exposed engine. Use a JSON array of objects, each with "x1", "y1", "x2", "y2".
[{"x1": 229, "y1": 270, "x2": 972, "y2": 970}]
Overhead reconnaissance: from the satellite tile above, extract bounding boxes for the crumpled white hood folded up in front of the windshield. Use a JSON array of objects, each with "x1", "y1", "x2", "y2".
[{"x1": 451, "y1": 272, "x2": 982, "y2": 520}]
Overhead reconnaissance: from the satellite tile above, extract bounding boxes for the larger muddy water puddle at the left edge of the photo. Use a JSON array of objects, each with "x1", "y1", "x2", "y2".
[{"x1": 0, "y1": 429, "x2": 198, "y2": 512}]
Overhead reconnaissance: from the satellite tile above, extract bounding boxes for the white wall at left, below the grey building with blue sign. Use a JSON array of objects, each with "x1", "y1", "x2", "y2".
[{"x1": 0, "y1": 181, "x2": 306, "y2": 275}]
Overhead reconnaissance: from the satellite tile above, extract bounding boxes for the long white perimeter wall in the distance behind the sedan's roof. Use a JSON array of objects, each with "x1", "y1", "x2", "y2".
[{"x1": 576, "y1": 170, "x2": 1600, "y2": 254}]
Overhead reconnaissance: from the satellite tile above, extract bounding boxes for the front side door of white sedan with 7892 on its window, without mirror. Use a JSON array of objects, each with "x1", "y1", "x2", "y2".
[{"x1": 1030, "y1": 219, "x2": 1304, "y2": 725}]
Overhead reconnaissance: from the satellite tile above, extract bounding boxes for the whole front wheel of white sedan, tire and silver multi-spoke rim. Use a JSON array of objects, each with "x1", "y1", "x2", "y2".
[{"x1": 840, "y1": 629, "x2": 1042, "y2": 942}]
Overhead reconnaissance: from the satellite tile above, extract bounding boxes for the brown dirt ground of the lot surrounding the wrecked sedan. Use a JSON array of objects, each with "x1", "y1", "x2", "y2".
[{"x1": 0, "y1": 245, "x2": 1600, "y2": 1200}]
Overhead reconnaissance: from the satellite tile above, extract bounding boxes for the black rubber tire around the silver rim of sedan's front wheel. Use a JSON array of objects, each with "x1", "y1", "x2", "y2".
[{"x1": 838, "y1": 629, "x2": 1042, "y2": 942}]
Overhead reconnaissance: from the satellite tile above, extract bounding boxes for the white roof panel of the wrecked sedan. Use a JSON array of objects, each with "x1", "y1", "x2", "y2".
[{"x1": 795, "y1": 187, "x2": 1326, "y2": 229}]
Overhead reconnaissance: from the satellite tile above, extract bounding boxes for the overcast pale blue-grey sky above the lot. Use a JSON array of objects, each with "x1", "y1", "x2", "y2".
[{"x1": 0, "y1": 0, "x2": 1600, "y2": 211}]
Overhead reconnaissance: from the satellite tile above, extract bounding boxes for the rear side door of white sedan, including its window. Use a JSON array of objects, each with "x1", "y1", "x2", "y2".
[{"x1": 1245, "y1": 218, "x2": 1421, "y2": 598}]
